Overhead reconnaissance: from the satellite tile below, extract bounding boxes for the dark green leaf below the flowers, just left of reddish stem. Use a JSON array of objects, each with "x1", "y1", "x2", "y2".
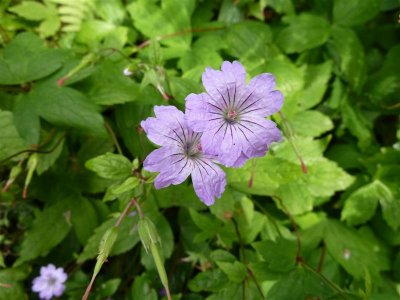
[{"x1": 252, "y1": 238, "x2": 297, "y2": 273}]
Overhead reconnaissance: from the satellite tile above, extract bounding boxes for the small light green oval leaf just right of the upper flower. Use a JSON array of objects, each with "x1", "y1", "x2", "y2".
[{"x1": 291, "y1": 110, "x2": 333, "y2": 137}]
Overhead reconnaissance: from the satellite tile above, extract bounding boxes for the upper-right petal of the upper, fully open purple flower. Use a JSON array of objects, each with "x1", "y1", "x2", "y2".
[{"x1": 237, "y1": 73, "x2": 283, "y2": 117}]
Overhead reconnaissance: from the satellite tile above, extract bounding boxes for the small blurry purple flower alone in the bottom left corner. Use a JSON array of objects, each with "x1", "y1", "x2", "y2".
[{"x1": 32, "y1": 264, "x2": 67, "y2": 300}]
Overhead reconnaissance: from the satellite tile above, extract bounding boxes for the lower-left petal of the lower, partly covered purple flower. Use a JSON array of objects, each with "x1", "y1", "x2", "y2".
[{"x1": 154, "y1": 156, "x2": 194, "y2": 189}]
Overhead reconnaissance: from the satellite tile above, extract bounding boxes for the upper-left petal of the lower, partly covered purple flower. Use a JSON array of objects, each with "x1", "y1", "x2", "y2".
[{"x1": 140, "y1": 106, "x2": 185, "y2": 146}]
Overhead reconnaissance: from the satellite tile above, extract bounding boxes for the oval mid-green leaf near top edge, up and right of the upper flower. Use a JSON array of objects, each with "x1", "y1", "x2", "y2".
[{"x1": 276, "y1": 14, "x2": 331, "y2": 53}]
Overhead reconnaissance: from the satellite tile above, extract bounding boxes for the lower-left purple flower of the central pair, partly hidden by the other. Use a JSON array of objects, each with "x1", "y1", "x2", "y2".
[{"x1": 141, "y1": 106, "x2": 226, "y2": 205}]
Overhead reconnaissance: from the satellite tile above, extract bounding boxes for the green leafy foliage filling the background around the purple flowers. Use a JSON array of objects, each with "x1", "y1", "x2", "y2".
[{"x1": 0, "y1": 0, "x2": 400, "y2": 300}]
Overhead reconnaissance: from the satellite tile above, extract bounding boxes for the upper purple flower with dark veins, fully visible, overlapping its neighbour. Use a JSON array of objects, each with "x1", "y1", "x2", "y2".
[{"x1": 186, "y1": 61, "x2": 283, "y2": 167}]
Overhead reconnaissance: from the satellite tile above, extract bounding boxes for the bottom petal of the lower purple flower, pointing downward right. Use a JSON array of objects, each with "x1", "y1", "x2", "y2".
[{"x1": 192, "y1": 159, "x2": 226, "y2": 206}]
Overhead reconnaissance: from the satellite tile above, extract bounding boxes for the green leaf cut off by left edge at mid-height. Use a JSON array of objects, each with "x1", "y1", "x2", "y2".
[{"x1": 0, "y1": 110, "x2": 26, "y2": 160}]
